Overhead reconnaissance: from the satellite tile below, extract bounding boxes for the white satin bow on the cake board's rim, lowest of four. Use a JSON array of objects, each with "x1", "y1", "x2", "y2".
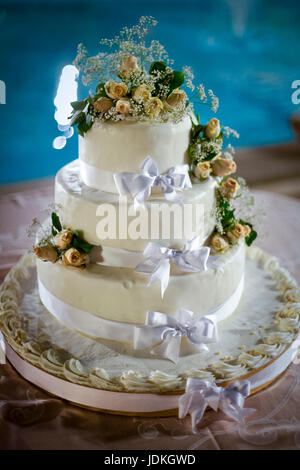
[{"x1": 178, "y1": 378, "x2": 256, "y2": 434}]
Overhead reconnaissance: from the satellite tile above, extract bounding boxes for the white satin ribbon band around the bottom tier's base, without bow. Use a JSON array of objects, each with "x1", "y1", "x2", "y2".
[{"x1": 38, "y1": 278, "x2": 243, "y2": 343}]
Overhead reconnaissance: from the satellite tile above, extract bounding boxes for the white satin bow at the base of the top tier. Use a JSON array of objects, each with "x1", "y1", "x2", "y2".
[{"x1": 114, "y1": 157, "x2": 192, "y2": 209}]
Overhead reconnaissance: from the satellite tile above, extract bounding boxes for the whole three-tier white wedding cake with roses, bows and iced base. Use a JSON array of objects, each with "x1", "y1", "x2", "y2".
[{"x1": 0, "y1": 18, "x2": 299, "y2": 425}]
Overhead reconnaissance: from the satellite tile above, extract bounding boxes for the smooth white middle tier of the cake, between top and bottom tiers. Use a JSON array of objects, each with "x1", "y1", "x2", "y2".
[{"x1": 55, "y1": 160, "x2": 217, "y2": 251}]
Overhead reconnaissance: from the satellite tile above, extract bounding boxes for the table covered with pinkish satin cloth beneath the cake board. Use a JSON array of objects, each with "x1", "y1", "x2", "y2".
[{"x1": 0, "y1": 180, "x2": 300, "y2": 450}]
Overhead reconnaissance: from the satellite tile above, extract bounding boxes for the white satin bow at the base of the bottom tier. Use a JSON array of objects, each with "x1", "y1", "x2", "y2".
[{"x1": 134, "y1": 308, "x2": 218, "y2": 363}]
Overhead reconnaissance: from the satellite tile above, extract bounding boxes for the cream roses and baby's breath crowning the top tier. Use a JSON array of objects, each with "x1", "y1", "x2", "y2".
[{"x1": 70, "y1": 16, "x2": 218, "y2": 135}]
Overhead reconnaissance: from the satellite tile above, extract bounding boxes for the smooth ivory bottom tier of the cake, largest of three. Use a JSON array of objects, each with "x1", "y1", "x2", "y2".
[{"x1": 37, "y1": 241, "x2": 245, "y2": 326}]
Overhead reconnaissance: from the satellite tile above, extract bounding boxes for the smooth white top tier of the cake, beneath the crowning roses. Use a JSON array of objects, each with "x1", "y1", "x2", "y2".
[{"x1": 79, "y1": 116, "x2": 192, "y2": 193}]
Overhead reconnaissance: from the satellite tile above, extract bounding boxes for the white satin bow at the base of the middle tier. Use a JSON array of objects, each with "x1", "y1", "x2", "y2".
[{"x1": 135, "y1": 237, "x2": 210, "y2": 297}]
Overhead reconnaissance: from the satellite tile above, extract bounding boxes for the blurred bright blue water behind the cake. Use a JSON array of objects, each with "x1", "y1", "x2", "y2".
[{"x1": 0, "y1": 0, "x2": 300, "y2": 183}]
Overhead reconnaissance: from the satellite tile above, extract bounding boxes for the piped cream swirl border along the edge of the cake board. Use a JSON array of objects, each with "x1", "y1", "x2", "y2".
[{"x1": 0, "y1": 247, "x2": 300, "y2": 393}]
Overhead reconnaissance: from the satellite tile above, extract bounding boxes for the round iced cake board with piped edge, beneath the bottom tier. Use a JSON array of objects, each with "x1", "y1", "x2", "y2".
[{"x1": 0, "y1": 248, "x2": 300, "y2": 416}]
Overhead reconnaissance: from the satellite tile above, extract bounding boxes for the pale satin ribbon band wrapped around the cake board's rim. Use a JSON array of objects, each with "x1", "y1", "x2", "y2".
[{"x1": 5, "y1": 340, "x2": 297, "y2": 417}]
